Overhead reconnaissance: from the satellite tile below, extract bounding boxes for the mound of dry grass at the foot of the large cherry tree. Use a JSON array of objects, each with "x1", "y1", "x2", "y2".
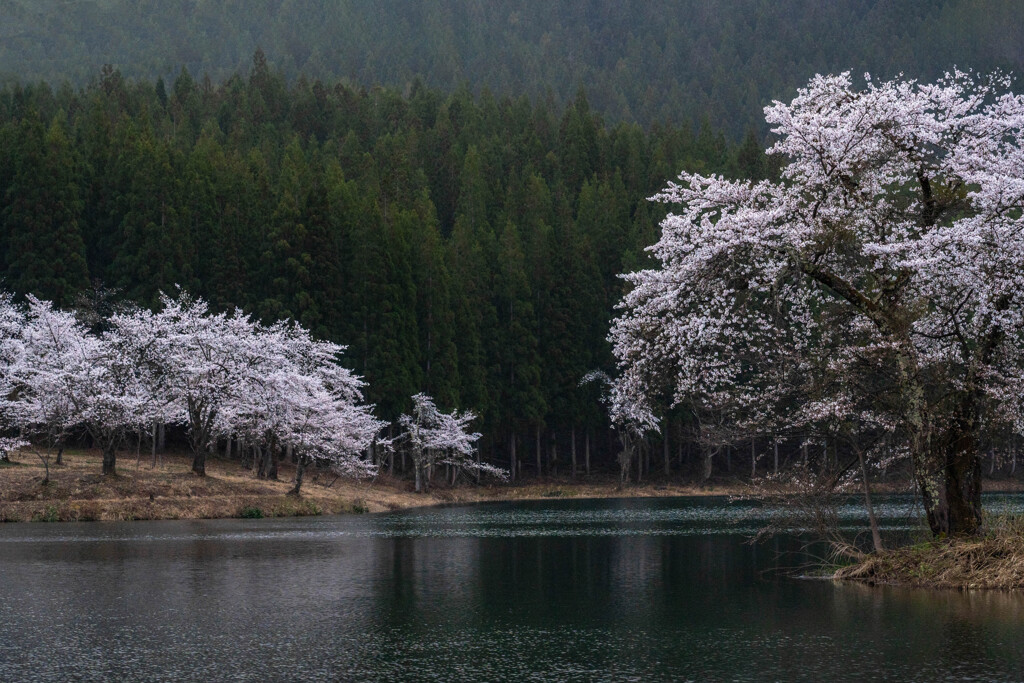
[{"x1": 834, "y1": 516, "x2": 1024, "y2": 590}]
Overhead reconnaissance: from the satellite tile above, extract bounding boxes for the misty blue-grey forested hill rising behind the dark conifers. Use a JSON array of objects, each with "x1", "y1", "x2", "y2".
[{"x1": 0, "y1": 0, "x2": 1024, "y2": 139}]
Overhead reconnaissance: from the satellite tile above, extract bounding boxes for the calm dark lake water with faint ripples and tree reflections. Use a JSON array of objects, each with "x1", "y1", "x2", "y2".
[{"x1": 0, "y1": 496, "x2": 1024, "y2": 681}]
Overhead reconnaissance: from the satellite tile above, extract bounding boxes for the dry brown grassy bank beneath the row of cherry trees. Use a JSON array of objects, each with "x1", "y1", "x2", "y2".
[{"x1": 0, "y1": 452, "x2": 741, "y2": 521}]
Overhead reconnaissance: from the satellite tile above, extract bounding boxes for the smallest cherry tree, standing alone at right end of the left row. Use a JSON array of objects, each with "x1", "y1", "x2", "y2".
[{"x1": 398, "y1": 393, "x2": 508, "y2": 494}]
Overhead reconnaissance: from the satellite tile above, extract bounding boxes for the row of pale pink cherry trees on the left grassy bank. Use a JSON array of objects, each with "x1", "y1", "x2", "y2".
[{"x1": 0, "y1": 294, "x2": 497, "y2": 494}]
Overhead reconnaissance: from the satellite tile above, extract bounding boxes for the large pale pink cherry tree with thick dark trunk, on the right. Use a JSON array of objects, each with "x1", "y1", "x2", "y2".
[{"x1": 610, "y1": 72, "x2": 1024, "y2": 533}]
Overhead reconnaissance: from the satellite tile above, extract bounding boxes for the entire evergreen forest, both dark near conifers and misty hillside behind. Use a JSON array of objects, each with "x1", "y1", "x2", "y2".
[{"x1": 0, "y1": 0, "x2": 1024, "y2": 476}]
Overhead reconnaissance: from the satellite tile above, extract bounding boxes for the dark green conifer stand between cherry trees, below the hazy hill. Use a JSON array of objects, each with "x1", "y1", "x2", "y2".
[{"x1": 0, "y1": 53, "x2": 768, "y2": 481}]
